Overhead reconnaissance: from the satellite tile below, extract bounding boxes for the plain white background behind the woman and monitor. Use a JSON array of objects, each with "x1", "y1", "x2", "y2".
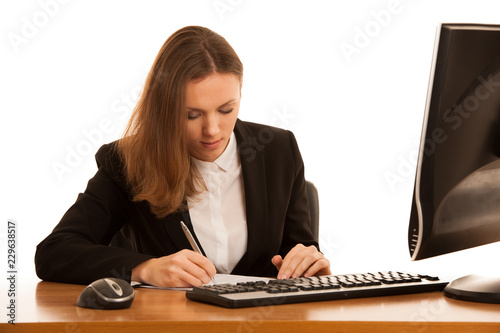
[{"x1": 0, "y1": 0, "x2": 500, "y2": 278}]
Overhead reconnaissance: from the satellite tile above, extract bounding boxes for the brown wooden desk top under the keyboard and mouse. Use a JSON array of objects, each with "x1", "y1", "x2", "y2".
[{"x1": 0, "y1": 279, "x2": 500, "y2": 333}]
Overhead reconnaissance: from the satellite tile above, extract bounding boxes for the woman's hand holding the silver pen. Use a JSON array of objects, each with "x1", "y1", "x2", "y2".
[{"x1": 132, "y1": 250, "x2": 216, "y2": 287}]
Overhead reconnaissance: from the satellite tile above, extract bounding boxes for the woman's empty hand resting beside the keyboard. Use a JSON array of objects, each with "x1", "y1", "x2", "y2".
[{"x1": 271, "y1": 244, "x2": 332, "y2": 279}]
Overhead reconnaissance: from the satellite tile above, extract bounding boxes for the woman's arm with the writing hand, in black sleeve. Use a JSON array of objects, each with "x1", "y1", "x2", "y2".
[{"x1": 35, "y1": 146, "x2": 215, "y2": 287}]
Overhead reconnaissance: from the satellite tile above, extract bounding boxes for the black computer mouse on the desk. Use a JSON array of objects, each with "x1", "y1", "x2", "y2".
[{"x1": 76, "y1": 278, "x2": 135, "y2": 310}]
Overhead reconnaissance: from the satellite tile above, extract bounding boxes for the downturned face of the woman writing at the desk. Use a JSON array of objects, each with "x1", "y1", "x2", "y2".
[{"x1": 186, "y1": 73, "x2": 241, "y2": 162}]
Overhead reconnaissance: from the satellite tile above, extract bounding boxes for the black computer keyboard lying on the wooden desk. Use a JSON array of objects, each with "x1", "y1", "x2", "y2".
[{"x1": 186, "y1": 271, "x2": 448, "y2": 308}]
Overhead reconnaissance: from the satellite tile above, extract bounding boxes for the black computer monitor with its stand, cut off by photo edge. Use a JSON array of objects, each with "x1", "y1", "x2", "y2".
[{"x1": 408, "y1": 24, "x2": 500, "y2": 303}]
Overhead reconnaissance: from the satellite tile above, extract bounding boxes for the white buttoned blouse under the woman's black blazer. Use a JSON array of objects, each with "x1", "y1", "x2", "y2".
[{"x1": 188, "y1": 133, "x2": 248, "y2": 274}]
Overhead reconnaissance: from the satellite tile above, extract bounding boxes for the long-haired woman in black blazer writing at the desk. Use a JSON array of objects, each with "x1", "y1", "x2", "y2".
[{"x1": 35, "y1": 26, "x2": 330, "y2": 287}]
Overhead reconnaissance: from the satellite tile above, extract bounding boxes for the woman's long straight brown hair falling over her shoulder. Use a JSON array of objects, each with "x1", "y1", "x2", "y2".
[{"x1": 118, "y1": 26, "x2": 243, "y2": 217}]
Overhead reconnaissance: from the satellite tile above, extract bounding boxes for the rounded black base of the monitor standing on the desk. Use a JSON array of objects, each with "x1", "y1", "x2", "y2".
[{"x1": 444, "y1": 275, "x2": 500, "y2": 304}]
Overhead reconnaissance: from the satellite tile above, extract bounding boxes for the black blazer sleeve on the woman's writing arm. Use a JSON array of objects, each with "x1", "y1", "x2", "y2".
[{"x1": 35, "y1": 145, "x2": 152, "y2": 284}]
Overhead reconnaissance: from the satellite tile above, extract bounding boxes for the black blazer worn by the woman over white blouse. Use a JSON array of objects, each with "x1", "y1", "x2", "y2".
[{"x1": 35, "y1": 120, "x2": 318, "y2": 284}]
